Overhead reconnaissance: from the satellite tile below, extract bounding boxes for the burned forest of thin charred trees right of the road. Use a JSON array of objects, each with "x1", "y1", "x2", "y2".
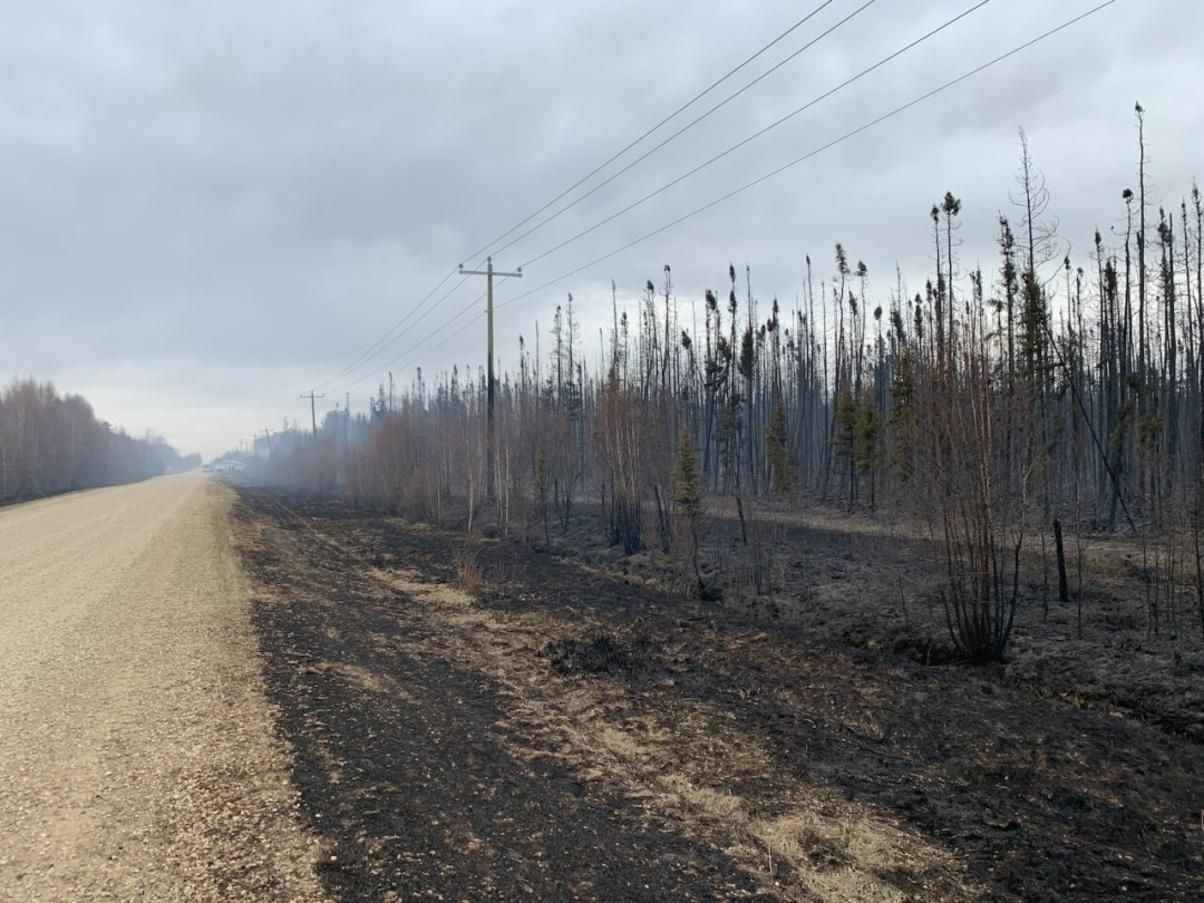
[{"x1": 258, "y1": 106, "x2": 1204, "y2": 663}]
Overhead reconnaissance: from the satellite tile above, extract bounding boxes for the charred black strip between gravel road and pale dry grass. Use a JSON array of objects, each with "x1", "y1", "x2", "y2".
[{"x1": 233, "y1": 507, "x2": 756, "y2": 901}]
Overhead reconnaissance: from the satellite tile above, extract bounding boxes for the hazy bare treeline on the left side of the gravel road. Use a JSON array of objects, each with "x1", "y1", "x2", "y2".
[{"x1": 0, "y1": 379, "x2": 200, "y2": 502}]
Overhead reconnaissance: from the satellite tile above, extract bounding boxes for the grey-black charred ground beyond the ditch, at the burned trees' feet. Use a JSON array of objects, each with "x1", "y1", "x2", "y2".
[{"x1": 553, "y1": 497, "x2": 1204, "y2": 746}]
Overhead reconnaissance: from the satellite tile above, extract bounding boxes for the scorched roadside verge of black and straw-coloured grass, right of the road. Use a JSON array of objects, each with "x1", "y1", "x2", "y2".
[{"x1": 235, "y1": 488, "x2": 1204, "y2": 901}]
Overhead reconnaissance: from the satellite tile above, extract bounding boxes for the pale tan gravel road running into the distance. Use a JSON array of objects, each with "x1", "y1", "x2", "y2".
[{"x1": 0, "y1": 474, "x2": 323, "y2": 902}]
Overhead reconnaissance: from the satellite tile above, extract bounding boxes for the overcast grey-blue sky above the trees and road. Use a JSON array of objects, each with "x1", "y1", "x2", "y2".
[{"x1": 0, "y1": 0, "x2": 1204, "y2": 455}]
